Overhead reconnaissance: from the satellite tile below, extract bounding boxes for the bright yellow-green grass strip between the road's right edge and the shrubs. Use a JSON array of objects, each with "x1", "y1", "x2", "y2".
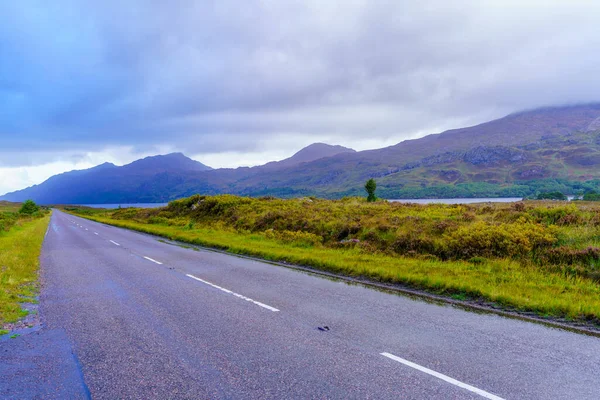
[{"x1": 69, "y1": 213, "x2": 600, "y2": 325}]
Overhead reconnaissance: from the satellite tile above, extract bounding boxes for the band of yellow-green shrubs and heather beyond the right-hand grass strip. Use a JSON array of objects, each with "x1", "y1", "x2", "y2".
[{"x1": 65, "y1": 195, "x2": 600, "y2": 266}]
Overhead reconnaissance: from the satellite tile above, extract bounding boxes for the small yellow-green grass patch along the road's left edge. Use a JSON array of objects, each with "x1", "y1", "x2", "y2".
[{"x1": 0, "y1": 206, "x2": 50, "y2": 334}]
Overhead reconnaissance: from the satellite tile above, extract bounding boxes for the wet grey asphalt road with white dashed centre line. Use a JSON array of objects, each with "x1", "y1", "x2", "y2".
[{"x1": 0, "y1": 211, "x2": 600, "y2": 399}]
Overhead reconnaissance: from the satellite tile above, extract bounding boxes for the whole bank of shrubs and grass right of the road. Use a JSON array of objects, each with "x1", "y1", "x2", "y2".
[{"x1": 70, "y1": 196, "x2": 600, "y2": 323}]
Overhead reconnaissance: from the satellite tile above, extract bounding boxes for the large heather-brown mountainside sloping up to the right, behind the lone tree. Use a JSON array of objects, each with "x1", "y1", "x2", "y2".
[{"x1": 186, "y1": 104, "x2": 600, "y2": 198}]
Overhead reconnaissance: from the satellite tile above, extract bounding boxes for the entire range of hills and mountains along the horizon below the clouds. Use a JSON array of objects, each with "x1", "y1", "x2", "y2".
[{"x1": 0, "y1": 103, "x2": 600, "y2": 204}]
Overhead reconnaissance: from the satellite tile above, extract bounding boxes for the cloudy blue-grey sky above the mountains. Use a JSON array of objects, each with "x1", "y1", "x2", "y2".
[{"x1": 0, "y1": 0, "x2": 600, "y2": 194}]
